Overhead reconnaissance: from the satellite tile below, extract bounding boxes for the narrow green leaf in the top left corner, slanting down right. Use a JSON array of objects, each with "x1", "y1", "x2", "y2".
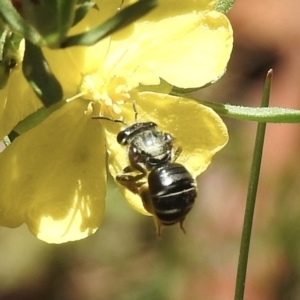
[{"x1": 0, "y1": 0, "x2": 45, "y2": 45}]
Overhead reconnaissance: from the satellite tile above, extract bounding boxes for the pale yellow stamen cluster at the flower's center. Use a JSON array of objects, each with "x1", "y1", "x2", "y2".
[{"x1": 80, "y1": 73, "x2": 133, "y2": 119}]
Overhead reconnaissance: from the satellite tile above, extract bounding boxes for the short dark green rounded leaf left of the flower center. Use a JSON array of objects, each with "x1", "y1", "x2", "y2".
[{"x1": 22, "y1": 41, "x2": 63, "y2": 106}]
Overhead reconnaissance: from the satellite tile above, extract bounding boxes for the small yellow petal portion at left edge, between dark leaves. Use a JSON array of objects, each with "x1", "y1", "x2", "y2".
[{"x1": 0, "y1": 68, "x2": 42, "y2": 140}]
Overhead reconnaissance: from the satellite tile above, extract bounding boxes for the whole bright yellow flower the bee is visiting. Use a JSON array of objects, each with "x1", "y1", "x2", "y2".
[{"x1": 0, "y1": 0, "x2": 232, "y2": 243}]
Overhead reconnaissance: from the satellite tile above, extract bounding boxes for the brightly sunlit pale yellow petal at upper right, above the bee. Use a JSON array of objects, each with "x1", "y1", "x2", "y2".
[{"x1": 104, "y1": 11, "x2": 233, "y2": 88}]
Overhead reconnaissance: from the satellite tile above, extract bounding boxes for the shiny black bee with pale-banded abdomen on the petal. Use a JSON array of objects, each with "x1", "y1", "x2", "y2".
[{"x1": 92, "y1": 102, "x2": 197, "y2": 236}]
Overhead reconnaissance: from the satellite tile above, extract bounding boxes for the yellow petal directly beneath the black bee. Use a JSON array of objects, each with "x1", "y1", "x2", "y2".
[{"x1": 101, "y1": 92, "x2": 228, "y2": 215}]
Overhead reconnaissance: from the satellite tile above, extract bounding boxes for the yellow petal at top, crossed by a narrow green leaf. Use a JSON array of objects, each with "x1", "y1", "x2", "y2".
[{"x1": 43, "y1": 0, "x2": 121, "y2": 79}]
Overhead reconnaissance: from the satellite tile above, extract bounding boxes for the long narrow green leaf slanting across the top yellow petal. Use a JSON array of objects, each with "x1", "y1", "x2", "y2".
[{"x1": 61, "y1": 0, "x2": 157, "y2": 48}]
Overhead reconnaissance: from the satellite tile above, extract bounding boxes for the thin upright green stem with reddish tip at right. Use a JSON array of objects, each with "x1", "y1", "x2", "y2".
[{"x1": 234, "y1": 70, "x2": 273, "y2": 300}]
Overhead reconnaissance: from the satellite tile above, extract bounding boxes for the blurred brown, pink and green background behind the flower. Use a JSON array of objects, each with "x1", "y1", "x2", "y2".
[{"x1": 0, "y1": 0, "x2": 300, "y2": 300}]
